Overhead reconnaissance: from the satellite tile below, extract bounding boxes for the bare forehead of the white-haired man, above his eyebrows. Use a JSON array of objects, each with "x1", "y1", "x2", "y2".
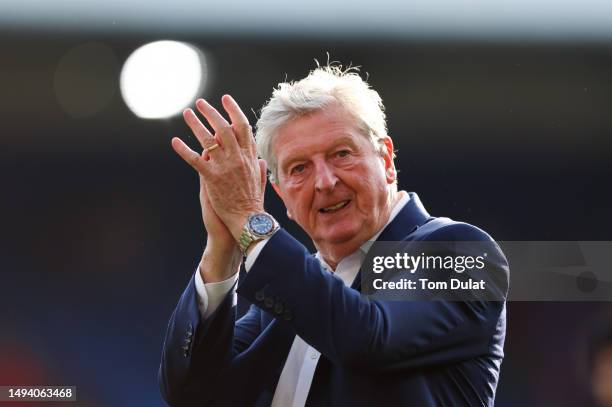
[{"x1": 273, "y1": 105, "x2": 368, "y2": 161}]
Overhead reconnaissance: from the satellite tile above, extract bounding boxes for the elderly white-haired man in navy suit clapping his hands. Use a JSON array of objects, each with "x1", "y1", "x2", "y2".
[{"x1": 159, "y1": 66, "x2": 507, "y2": 406}]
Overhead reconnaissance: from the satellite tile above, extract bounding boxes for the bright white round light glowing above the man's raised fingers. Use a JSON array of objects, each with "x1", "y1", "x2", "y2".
[{"x1": 120, "y1": 41, "x2": 207, "y2": 119}]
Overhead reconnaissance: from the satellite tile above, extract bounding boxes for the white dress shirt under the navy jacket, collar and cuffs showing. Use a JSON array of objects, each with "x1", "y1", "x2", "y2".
[{"x1": 195, "y1": 191, "x2": 410, "y2": 407}]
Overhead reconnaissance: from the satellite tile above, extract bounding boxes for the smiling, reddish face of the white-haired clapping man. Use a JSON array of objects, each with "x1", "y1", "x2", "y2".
[{"x1": 273, "y1": 105, "x2": 395, "y2": 260}]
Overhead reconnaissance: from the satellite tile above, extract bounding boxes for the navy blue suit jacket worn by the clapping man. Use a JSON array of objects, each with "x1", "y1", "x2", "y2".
[{"x1": 159, "y1": 193, "x2": 508, "y2": 406}]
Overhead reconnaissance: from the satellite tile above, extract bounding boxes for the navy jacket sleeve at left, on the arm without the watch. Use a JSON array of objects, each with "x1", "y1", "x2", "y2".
[{"x1": 158, "y1": 277, "x2": 260, "y2": 407}]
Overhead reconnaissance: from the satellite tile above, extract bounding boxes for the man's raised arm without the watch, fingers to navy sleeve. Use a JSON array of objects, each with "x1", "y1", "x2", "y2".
[{"x1": 159, "y1": 100, "x2": 265, "y2": 406}]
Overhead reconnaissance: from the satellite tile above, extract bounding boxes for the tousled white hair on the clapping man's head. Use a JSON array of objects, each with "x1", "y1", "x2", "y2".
[{"x1": 256, "y1": 65, "x2": 387, "y2": 184}]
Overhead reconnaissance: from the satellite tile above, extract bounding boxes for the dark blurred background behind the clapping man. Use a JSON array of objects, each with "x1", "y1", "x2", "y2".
[{"x1": 0, "y1": 0, "x2": 612, "y2": 407}]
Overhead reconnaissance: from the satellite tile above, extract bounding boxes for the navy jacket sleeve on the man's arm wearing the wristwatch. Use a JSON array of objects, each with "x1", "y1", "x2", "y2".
[{"x1": 238, "y1": 224, "x2": 508, "y2": 371}]
